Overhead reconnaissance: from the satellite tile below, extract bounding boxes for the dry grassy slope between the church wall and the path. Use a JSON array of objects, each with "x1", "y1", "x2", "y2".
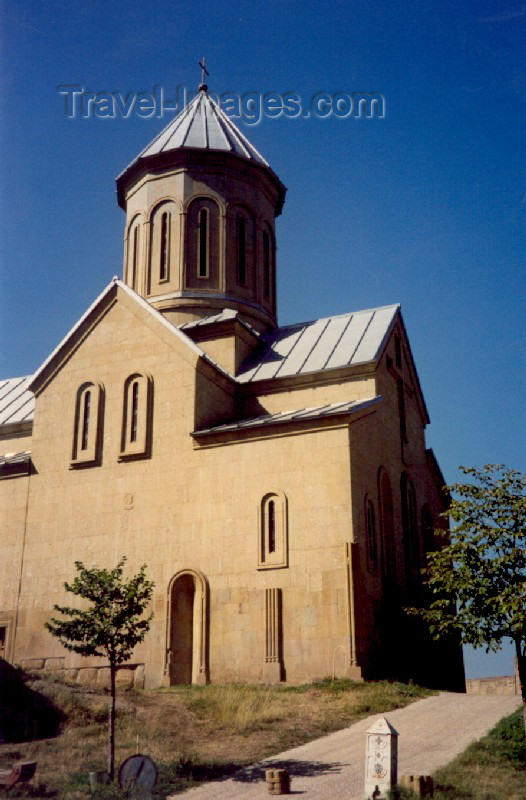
[{"x1": 0, "y1": 674, "x2": 432, "y2": 800}]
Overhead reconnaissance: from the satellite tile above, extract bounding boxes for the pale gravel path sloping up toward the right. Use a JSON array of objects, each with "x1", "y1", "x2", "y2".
[{"x1": 168, "y1": 692, "x2": 520, "y2": 800}]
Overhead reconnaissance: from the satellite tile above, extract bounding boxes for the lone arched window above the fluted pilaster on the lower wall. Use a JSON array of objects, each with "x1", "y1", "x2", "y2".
[{"x1": 258, "y1": 491, "x2": 289, "y2": 569}]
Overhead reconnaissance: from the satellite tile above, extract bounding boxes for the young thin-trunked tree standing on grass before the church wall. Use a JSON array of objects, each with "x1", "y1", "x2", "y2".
[{"x1": 45, "y1": 558, "x2": 154, "y2": 781}]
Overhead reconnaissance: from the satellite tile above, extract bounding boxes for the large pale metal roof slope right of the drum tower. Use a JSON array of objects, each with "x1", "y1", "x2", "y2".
[{"x1": 237, "y1": 305, "x2": 400, "y2": 383}]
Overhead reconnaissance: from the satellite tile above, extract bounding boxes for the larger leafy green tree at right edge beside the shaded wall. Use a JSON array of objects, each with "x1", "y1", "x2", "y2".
[{"x1": 409, "y1": 464, "x2": 526, "y2": 731}]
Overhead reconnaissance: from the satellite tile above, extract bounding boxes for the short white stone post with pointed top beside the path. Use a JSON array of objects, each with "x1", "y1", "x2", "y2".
[{"x1": 365, "y1": 717, "x2": 398, "y2": 800}]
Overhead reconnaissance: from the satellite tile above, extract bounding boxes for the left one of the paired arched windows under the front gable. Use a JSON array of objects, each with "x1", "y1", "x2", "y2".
[{"x1": 71, "y1": 381, "x2": 104, "y2": 467}]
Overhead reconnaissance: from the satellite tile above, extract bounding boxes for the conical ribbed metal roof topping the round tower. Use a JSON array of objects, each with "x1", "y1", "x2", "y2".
[{"x1": 117, "y1": 91, "x2": 269, "y2": 180}]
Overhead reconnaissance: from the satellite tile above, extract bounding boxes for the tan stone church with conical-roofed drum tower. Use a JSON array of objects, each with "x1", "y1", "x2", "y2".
[{"x1": 0, "y1": 84, "x2": 463, "y2": 690}]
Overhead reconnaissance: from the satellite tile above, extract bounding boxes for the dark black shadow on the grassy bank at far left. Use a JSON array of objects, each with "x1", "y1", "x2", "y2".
[{"x1": 0, "y1": 659, "x2": 64, "y2": 742}]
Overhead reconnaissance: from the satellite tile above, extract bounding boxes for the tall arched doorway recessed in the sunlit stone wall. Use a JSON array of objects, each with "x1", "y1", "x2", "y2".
[{"x1": 165, "y1": 570, "x2": 208, "y2": 686}]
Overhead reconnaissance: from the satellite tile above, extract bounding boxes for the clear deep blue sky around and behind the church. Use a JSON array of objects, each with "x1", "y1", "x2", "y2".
[{"x1": 0, "y1": 0, "x2": 526, "y2": 676}]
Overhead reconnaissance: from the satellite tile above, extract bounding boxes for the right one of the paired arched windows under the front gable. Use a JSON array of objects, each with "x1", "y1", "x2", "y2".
[{"x1": 119, "y1": 372, "x2": 153, "y2": 461}]
